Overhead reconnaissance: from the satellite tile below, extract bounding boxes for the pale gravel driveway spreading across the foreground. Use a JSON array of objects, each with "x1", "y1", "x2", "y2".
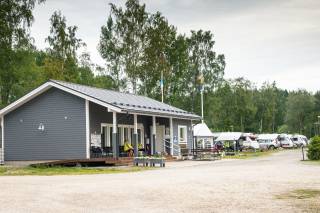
[{"x1": 0, "y1": 150, "x2": 320, "y2": 213}]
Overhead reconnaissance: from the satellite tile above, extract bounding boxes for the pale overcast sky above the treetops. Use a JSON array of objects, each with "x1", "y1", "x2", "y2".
[{"x1": 31, "y1": 0, "x2": 320, "y2": 91}]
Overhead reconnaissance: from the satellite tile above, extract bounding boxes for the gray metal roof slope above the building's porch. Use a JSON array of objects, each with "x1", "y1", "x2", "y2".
[{"x1": 50, "y1": 80, "x2": 201, "y2": 120}]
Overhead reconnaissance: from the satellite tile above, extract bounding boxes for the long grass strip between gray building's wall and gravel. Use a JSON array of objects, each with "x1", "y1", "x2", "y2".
[{"x1": 0, "y1": 166, "x2": 151, "y2": 176}]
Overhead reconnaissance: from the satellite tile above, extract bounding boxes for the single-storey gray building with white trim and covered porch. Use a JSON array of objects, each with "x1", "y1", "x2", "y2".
[{"x1": 0, "y1": 80, "x2": 200, "y2": 163}]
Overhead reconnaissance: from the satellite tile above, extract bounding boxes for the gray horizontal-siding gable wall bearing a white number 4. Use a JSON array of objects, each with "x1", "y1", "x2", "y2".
[{"x1": 4, "y1": 88, "x2": 86, "y2": 161}]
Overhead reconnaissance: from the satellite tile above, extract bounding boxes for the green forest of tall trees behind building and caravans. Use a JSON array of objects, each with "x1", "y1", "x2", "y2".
[{"x1": 0, "y1": 0, "x2": 320, "y2": 136}]
